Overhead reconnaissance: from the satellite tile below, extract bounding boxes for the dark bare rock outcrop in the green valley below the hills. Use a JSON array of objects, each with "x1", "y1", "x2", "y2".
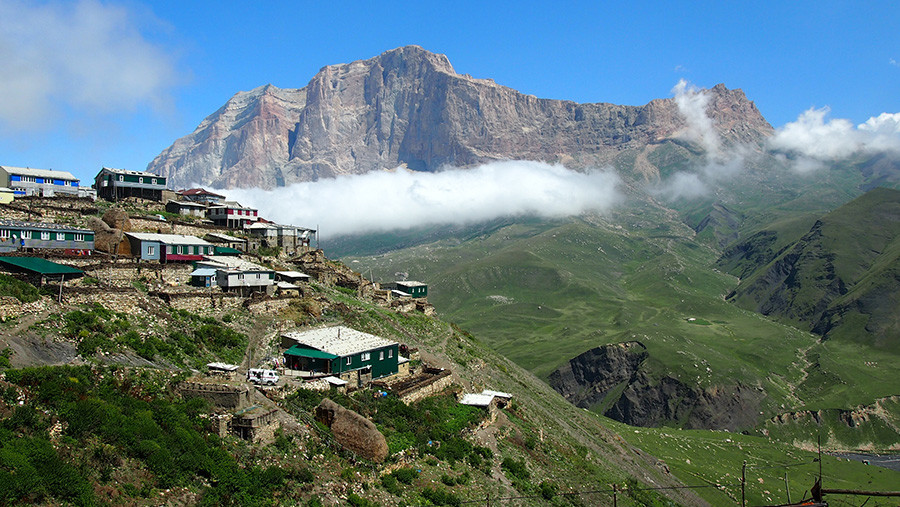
[{"x1": 549, "y1": 342, "x2": 765, "y2": 431}]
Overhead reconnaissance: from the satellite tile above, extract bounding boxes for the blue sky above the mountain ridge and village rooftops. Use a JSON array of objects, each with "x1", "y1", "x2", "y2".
[{"x1": 0, "y1": 0, "x2": 900, "y2": 180}]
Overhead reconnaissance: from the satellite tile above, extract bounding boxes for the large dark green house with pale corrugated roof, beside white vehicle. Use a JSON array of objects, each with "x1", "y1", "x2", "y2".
[{"x1": 281, "y1": 326, "x2": 400, "y2": 387}]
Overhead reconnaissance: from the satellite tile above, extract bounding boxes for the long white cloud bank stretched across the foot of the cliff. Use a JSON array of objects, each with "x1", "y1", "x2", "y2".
[{"x1": 219, "y1": 161, "x2": 621, "y2": 237}]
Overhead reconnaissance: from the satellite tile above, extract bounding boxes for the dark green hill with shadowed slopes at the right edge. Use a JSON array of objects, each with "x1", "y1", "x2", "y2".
[{"x1": 720, "y1": 188, "x2": 900, "y2": 354}]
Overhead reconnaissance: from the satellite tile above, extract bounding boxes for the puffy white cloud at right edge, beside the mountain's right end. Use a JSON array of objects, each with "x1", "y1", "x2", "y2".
[{"x1": 769, "y1": 107, "x2": 900, "y2": 167}]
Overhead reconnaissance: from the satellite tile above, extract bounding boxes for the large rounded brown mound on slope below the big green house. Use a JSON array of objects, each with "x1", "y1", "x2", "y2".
[{"x1": 316, "y1": 398, "x2": 388, "y2": 463}]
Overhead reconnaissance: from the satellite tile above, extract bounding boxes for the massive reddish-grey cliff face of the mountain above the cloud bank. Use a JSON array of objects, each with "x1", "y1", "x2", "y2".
[{"x1": 147, "y1": 46, "x2": 772, "y2": 188}]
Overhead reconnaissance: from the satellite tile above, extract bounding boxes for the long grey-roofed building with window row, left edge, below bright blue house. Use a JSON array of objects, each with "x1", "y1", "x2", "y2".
[{"x1": 0, "y1": 220, "x2": 94, "y2": 253}]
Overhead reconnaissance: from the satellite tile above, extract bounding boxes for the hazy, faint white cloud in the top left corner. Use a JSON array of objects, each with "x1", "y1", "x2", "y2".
[{"x1": 0, "y1": 0, "x2": 177, "y2": 131}]
